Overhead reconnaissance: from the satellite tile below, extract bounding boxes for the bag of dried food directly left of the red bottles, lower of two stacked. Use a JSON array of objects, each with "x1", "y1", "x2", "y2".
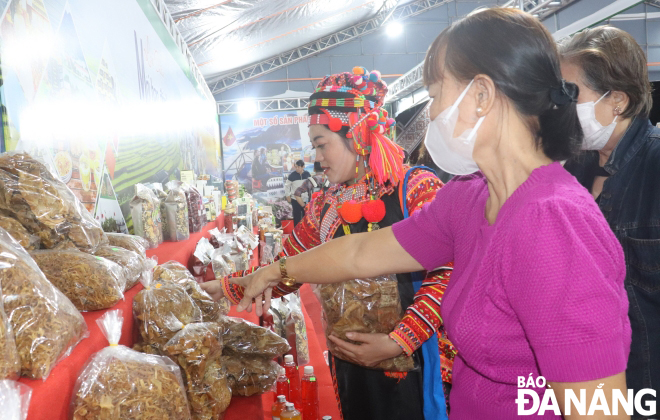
[{"x1": 222, "y1": 354, "x2": 280, "y2": 397}]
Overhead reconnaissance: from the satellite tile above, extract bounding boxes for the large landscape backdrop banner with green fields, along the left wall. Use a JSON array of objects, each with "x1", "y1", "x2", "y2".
[{"x1": 0, "y1": 0, "x2": 222, "y2": 232}]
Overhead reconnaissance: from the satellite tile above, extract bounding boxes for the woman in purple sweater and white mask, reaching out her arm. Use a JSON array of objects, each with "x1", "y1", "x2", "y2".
[{"x1": 236, "y1": 8, "x2": 631, "y2": 420}]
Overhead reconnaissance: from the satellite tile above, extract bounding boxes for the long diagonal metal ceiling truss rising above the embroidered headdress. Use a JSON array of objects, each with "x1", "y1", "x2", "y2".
[{"x1": 209, "y1": 0, "x2": 454, "y2": 95}]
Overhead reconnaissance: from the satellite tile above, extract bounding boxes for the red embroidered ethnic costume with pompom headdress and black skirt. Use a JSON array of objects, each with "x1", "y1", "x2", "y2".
[{"x1": 222, "y1": 69, "x2": 455, "y2": 420}]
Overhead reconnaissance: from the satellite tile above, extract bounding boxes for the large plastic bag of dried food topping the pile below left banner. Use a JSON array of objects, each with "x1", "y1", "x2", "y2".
[{"x1": 0, "y1": 153, "x2": 107, "y2": 252}]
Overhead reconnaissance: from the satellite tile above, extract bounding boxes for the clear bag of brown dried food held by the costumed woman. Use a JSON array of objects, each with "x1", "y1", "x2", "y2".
[{"x1": 316, "y1": 274, "x2": 415, "y2": 372}]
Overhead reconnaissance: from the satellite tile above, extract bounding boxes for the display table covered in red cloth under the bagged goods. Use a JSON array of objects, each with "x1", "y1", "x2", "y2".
[{"x1": 20, "y1": 220, "x2": 340, "y2": 420}]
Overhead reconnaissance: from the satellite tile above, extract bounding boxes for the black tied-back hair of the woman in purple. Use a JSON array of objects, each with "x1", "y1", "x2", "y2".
[{"x1": 424, "y1": 7, "x2": 583, "y2": 161}]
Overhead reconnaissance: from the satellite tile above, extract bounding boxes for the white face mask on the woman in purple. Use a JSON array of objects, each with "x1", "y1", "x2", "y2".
[{"x1": 424, "y1": 80, "x2": 485, "y2": 175}]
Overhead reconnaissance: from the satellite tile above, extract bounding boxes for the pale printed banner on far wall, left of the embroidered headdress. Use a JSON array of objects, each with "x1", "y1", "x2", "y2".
[{"x1": 220, "y1": 111, "x2": 315, "y2": 205}]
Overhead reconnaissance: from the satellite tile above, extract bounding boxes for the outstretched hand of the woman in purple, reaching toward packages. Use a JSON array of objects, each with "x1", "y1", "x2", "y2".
[{"x1": 229, "y1": 263, "x2": 281, "y2": 316}]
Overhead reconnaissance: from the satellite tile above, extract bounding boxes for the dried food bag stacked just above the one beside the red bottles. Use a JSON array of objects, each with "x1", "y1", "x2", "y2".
[{"x1": 224, "y1": 317, "x2": 291, "y2": 359}]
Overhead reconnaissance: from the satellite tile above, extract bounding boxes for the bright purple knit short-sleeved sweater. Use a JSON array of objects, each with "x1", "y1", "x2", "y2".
[{"x1": 393, "y1": 163, "x2": 631, "y2": 420}]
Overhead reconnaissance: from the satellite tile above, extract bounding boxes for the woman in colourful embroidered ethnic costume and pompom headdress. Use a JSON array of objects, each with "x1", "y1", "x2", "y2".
[{"x1": 203, "y1": 67, "x2": 455, "y2": 420}]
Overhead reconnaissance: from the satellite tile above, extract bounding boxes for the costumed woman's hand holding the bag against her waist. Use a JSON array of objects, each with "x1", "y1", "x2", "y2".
[{"x1": 329, "y1": 333, "x2": 403, "y2": 367}]
